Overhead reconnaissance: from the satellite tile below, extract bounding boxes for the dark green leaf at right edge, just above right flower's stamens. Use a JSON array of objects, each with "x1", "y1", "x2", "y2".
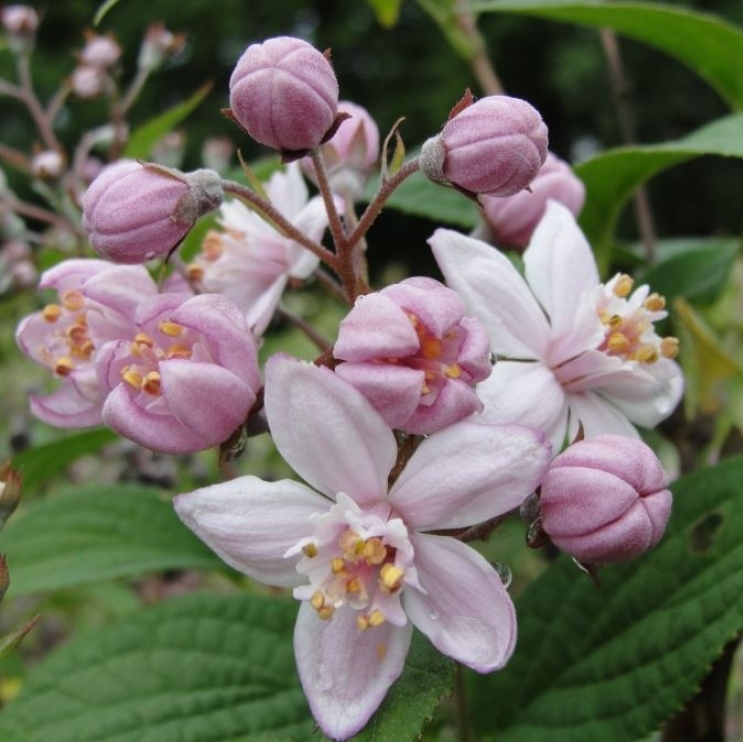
[{"x1": 635, "y1": 238, "x2": 740, "y2": 304}]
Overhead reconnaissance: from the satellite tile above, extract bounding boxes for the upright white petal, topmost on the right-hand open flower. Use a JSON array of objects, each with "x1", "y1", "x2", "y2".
[{"x1": 524, "y1": 201, "x2": 599, "y2": 335}]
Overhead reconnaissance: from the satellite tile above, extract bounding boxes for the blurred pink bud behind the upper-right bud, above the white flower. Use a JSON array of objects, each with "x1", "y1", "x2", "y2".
[{"x1": 480, "y1": 152, "x2": 586, "y2": 249}]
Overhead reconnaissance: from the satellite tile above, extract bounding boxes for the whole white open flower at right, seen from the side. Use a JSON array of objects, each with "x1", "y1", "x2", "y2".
[{"x1": 430, "y1": 201, "x2": 683, "y2": 451}]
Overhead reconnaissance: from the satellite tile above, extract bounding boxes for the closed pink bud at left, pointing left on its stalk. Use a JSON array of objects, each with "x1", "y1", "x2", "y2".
[{"x1": 83, "y1": 160, "x2": 223, "y2": 263}]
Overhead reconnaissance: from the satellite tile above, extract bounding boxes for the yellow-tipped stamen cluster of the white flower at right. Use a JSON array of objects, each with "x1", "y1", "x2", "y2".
[{"x1": 597, "y1": 273, "x2": 679, "y2": 363}]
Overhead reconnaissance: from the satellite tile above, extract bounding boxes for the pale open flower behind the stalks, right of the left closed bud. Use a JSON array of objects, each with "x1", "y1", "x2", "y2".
[{"x1": 188, "y1": 163, "x2": 328, "y2": 335}]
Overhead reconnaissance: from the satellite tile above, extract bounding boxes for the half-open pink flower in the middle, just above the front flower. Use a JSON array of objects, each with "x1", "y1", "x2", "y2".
[{"x1": 333, "y1": 278, "x2": 492, "y2": 434}]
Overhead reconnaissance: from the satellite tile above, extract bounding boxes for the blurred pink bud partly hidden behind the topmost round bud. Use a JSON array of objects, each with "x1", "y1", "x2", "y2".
[{"x1": 301, "y1": 101, "x2": 379, "y2": 200}]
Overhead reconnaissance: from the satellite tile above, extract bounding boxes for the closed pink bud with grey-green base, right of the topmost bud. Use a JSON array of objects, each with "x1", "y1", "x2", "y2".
[{"x1": 420, "y1": 95, "x2": 547, "y2": 196}]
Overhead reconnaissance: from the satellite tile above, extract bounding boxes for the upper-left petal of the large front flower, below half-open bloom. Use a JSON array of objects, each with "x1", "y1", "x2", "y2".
[{"x1": 265, "y1": 354, "x2": 397, "y2": 505}]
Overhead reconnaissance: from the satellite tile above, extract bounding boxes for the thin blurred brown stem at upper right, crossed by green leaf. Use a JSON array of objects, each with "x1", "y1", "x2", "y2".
[{"x1": 601, "y1": 28, "x2": 655, "y2": 262}]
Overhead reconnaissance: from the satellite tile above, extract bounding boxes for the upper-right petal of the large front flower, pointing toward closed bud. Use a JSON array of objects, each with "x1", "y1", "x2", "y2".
[{"x1": 389, "y1": 421, "x2": 550, "y2": 531}]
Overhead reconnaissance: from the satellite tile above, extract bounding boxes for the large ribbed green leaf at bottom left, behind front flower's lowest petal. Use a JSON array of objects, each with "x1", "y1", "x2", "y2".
[{"x1": 0, "y1": 594, "x2": 452, "y2": 742}]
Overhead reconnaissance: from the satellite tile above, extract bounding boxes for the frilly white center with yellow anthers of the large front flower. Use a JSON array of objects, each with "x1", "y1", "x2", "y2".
[{"x1": 290, "y1": 495, "x2": 417, "y2": 631}]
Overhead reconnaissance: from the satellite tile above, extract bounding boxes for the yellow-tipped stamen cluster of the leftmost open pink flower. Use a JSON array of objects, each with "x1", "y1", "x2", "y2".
[{"x1": 39, "y1": 291, "x2": 95, "y2": 377}]
